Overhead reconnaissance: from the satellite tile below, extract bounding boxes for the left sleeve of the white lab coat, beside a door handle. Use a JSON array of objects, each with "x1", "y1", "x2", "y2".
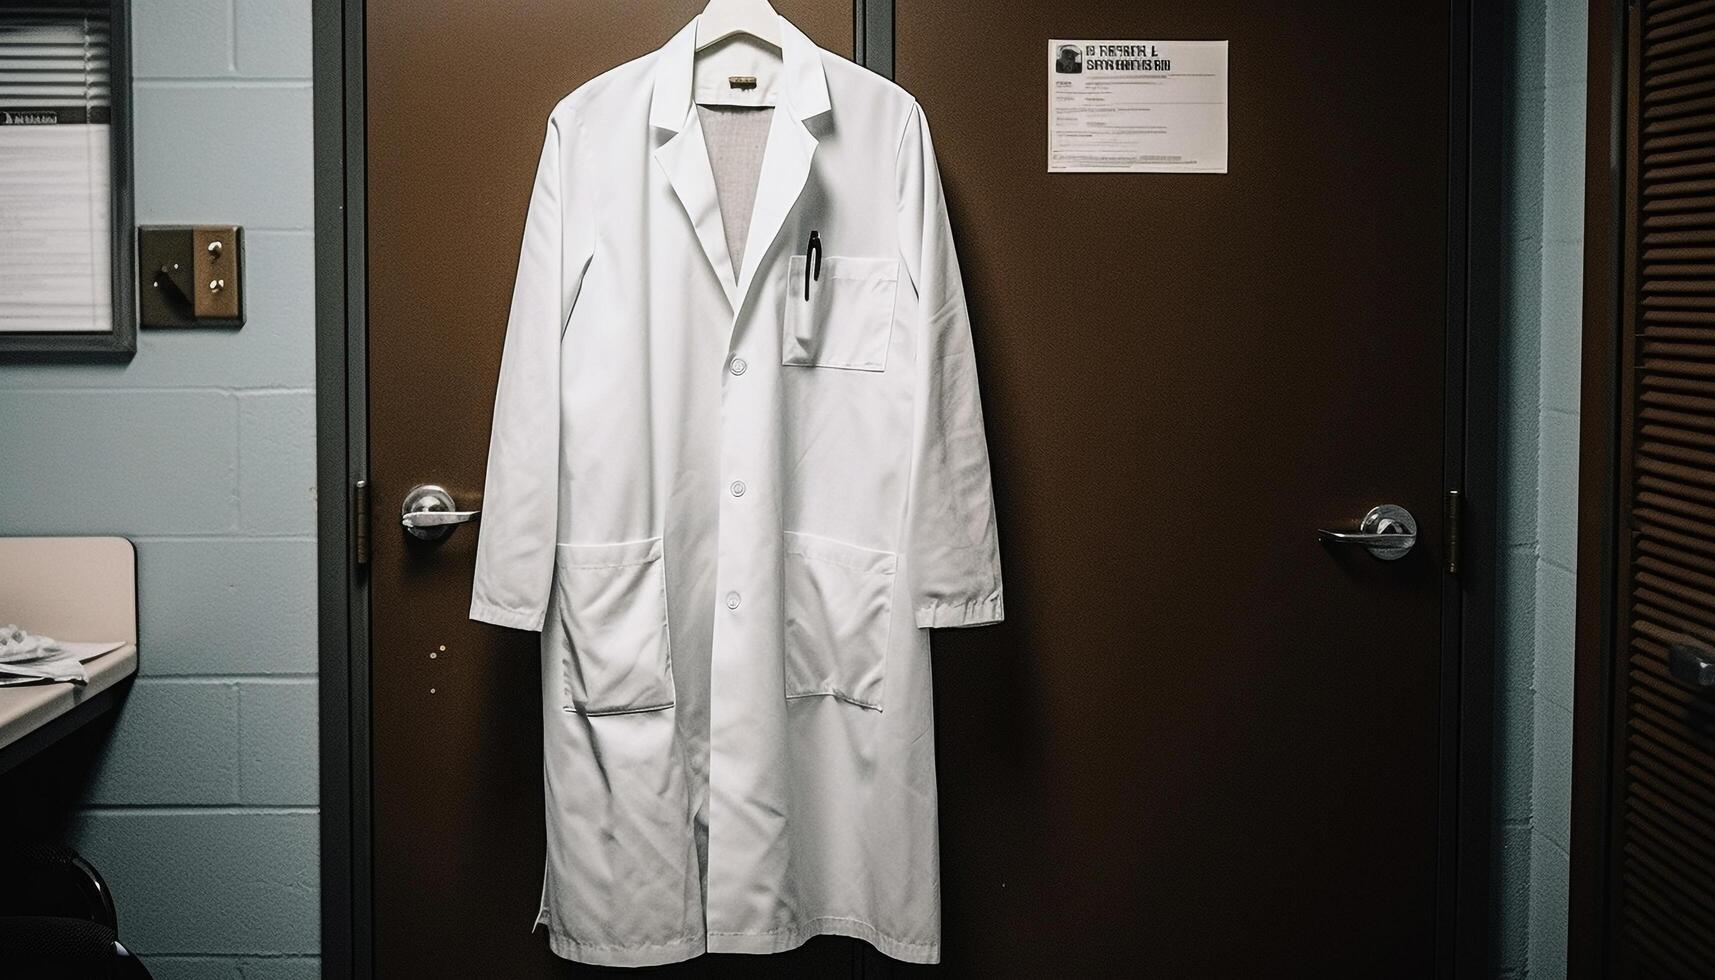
[{"x1": 470, "y1": 107, "x2": 592, "y2": 630}]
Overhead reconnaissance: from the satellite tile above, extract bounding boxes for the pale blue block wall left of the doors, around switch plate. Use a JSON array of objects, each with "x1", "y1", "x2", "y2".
[{"x1": 0, "y1": 0, "x2": 321, "y2": 980}]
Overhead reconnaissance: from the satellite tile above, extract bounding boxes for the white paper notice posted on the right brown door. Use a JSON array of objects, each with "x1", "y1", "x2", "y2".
[{"x1": 1048, "y1": 39, "x2": 1226, "y2": 173}]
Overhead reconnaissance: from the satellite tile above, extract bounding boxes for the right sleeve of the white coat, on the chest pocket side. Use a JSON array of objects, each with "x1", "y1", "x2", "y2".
[{"x1": 897, "y1": 105, "x2": 1003, "y2": 628}]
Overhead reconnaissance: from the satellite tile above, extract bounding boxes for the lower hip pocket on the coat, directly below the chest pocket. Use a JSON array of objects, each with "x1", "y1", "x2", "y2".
[{"x1": 785, "y1": 530, "x2": 895, "y2": 711}]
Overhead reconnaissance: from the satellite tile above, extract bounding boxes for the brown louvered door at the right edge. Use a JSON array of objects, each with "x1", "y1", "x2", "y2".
[{"x1": 1569, "y1": 2, "x2": 1715, "y2": 980}]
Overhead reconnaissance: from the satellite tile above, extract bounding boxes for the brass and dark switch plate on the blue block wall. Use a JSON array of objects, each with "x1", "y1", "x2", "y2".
[{"x1": 137, "y1": 225, "x2": 244, "y2": 328}]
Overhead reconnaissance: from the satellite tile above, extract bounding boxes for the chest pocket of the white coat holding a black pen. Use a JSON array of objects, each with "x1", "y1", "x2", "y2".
[{"x1": 780, "y1": 256, "x2": 899, "y2": 371}]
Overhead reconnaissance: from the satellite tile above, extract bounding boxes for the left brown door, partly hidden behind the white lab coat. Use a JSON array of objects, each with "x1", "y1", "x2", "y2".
[{"x1": 365, "y1": 0, "x2": 852, "y2": 978}]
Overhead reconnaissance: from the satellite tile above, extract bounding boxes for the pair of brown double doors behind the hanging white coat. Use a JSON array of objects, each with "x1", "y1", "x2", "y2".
[{"x1": 365, "y1": 0, "x2": 1449, "y2": 977}]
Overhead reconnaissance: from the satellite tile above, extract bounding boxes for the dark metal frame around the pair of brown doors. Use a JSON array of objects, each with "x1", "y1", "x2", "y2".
[{"x1": 312, "y1": 0, "x2": 1495, "y2": 980}]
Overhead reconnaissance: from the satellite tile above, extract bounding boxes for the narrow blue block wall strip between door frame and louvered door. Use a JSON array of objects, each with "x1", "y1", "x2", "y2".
[{"x1": 1494, "y1": 0, "x2": 1588, "y2": 978}]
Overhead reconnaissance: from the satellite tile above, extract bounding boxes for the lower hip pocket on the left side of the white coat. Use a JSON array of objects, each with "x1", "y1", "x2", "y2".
[{"x1": 554, "y1": 537, "x2": 674, "y2": 714}]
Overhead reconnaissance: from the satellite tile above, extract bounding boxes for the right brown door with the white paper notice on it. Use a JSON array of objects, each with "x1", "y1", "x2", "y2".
[{"x1": 895, "y1": 0, "x2": 1449, "y2": 978}]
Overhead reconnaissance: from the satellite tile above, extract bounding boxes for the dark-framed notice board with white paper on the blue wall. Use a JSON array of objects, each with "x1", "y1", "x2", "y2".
[{"x1": 0, "y1": 0, "x2": 137, "y2": 359}]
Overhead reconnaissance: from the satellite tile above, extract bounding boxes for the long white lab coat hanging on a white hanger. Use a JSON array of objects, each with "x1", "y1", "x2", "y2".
[{"x1": 470, "y1": 13, "x2": 1002, "y2": 966}]
